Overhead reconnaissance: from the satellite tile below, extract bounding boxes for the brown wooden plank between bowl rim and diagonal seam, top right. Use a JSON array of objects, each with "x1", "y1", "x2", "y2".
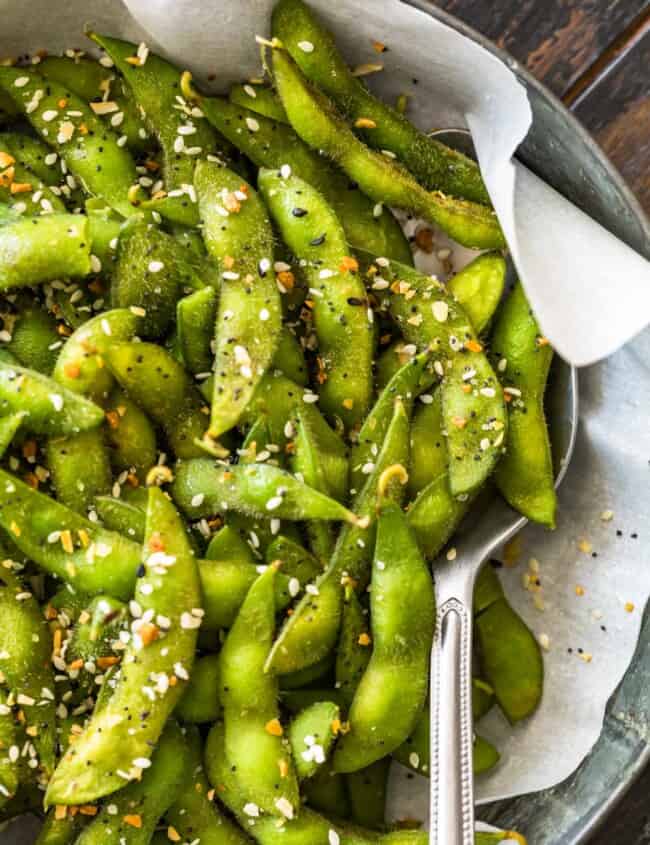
[{"x1": 428, "y1": 0, "x2": 648, "y2": 96}]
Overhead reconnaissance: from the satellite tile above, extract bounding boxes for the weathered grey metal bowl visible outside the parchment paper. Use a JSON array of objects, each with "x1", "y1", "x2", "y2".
[{"x1": 407, "y1": 0, "x2": 650, "y2": 845}]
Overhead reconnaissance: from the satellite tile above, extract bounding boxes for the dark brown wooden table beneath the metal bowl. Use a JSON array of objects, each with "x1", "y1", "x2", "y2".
[{"x1": 434, "y1": 0, "x2": 650, "y2": 845}]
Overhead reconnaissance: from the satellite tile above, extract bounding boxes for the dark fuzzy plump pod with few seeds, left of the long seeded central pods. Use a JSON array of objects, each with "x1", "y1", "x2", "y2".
[{"x1": 111, "y1": 220, "x2": 194, "y2": 338}]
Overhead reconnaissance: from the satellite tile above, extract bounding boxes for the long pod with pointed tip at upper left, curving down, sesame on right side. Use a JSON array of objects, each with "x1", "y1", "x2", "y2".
[{"x1": 89, "y1": 32, "x2": 217, "y2": 226}]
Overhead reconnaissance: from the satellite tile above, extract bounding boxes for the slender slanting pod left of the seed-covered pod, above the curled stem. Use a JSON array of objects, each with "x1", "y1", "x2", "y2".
[{"x1": 350, "y1": 350, "x2": 436, "y2": 495}]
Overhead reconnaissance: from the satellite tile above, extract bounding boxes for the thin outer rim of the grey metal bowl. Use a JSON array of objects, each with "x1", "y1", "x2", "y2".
[{"x1": 402, "y1": 0, "x2": 650, "y2": 845}]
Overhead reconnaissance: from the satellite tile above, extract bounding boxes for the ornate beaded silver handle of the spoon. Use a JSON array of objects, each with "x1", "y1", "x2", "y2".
[{"x1": 429, "y1": 565, "x2": 474, "y2": 845}]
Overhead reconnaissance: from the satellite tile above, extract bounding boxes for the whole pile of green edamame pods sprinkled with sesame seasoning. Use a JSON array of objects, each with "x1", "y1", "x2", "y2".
[{"x1": 0, "y1": 0, "x2": 555, "y2": 845}]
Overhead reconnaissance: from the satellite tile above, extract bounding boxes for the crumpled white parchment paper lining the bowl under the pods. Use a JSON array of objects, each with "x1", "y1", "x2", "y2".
[{"x1": 0, "y1": 0, "x2": 650, "y2": 818}]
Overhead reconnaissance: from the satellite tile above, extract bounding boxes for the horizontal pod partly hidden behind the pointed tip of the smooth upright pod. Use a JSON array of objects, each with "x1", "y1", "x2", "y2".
[{"x1": 198, "y1": 557, "x2": 291, "y2": 633}]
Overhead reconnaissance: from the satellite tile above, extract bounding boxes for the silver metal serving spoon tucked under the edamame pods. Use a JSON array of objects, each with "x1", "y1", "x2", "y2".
[{"x1": 429, "y1": 129, "x2": 578, "y2": 845}]
